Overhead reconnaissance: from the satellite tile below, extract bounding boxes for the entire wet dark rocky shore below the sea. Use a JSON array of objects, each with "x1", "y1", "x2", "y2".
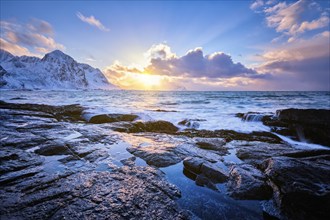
[{"x1": 0, "y1": 101, "x2": 330, "y2": 219}]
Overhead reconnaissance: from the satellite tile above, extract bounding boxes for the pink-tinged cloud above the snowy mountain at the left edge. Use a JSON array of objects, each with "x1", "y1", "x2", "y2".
[{"x1": 0, "y1": 19, "x2": 65, "y2": 56}]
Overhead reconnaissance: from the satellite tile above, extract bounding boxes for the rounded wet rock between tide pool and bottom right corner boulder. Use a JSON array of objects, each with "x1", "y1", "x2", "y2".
[{"x1": 227, "y1": 164, "x2": 272, "y2": 200}]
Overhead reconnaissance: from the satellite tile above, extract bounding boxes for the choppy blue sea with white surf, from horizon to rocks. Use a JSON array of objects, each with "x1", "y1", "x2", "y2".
[{"x1": 0, "y1": 90, "x2": 330, "y2": 133}]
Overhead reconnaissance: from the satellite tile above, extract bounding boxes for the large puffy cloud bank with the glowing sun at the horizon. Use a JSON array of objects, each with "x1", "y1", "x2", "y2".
[{"x1": 104, "y1": 44, "x2": 270, "y2": 90}]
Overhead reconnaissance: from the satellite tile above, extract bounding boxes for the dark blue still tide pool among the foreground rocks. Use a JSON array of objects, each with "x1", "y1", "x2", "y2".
[{"x1": 161, "y1": 162, "x2": 263, "y2": 219}]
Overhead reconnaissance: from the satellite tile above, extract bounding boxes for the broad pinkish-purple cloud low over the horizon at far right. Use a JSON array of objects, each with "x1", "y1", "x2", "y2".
[{"x1": 257, "y1": 31, "x2": 330, "y2": 91}]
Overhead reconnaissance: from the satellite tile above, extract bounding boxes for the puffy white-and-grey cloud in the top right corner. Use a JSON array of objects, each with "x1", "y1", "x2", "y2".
[{"x1": 251, "y1": 0, "x2": 329, "y2": 42}]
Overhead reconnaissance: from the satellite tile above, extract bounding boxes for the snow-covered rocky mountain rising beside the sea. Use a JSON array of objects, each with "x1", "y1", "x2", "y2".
[{"x1": 0, "y1": 49, "x2": 116, "y2": 90}]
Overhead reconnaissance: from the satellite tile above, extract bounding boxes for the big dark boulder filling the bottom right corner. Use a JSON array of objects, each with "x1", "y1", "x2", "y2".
[{"x1": 263, "y1": 155, "x2": 330, "y2": 219}]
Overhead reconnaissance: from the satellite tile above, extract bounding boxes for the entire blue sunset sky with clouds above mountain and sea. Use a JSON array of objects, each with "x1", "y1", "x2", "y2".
[{"x1": 0, "y1": 0, "x2": 330, "y2": 91}]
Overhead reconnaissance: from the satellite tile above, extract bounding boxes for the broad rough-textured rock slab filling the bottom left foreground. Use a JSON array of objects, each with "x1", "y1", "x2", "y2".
[{"x1": 0, "y1": 167, "x2": 188, "y2": 219}]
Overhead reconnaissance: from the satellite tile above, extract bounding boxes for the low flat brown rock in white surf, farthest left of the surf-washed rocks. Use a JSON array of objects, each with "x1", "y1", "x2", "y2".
[{"x1": 88, "y1": 114, "x2": 139, "y2": 124}]
